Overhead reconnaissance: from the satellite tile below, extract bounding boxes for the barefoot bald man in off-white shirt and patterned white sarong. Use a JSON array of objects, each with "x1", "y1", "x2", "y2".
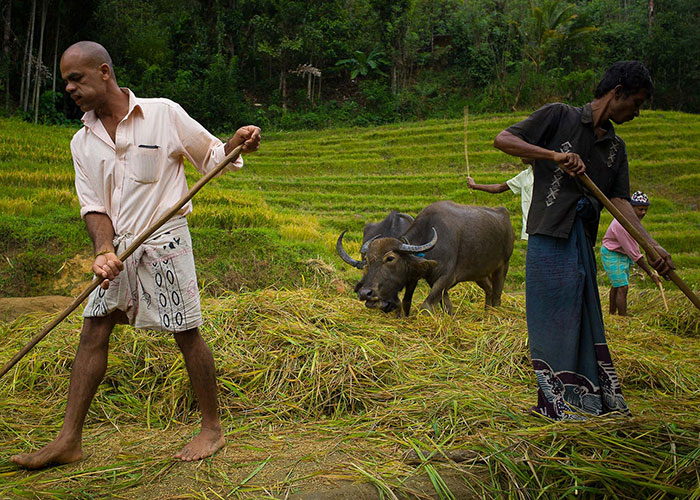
[{"x1": 11, "y1": 41, "x2": 260, "y2": 469}]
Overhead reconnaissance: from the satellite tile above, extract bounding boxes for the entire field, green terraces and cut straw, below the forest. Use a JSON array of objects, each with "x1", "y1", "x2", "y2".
[{"x1": 0, "y1": 112, "x2": 700, "y2": 499}]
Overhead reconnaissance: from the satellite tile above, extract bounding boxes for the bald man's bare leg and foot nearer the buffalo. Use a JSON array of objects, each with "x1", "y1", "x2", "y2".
[{"x1": 174, "y1": 328, "x2": 225, "y2": 462}]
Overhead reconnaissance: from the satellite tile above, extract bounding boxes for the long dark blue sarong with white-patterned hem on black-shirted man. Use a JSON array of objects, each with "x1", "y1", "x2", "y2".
[{"x1": 525, "y1": 198, "x2": 630, "y2": 420}]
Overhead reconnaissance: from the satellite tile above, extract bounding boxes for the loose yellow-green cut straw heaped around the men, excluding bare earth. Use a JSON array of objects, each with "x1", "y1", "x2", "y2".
[{"x1": 0, "y1": 284, "x2": 700, "y2": 498}]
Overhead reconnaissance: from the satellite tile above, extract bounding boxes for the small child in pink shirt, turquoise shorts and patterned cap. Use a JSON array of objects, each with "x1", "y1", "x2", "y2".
[{"x1": 600, "y1": 191, "x2": 660, "y2": 316}]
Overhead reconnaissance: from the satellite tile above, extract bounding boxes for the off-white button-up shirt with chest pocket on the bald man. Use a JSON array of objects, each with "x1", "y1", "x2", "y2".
[{"x1": 70, "y1": 89, "x2": 243, "y2": 235}]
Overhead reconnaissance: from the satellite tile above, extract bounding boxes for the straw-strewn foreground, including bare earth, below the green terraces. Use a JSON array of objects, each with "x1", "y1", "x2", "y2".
[{"x1": 0, "y1": 285, "x2": 700, "y2": 498}]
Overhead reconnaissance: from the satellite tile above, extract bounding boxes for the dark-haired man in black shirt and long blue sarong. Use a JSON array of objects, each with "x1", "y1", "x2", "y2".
[{"x1": 494, "y1": 61, "x2": 673, "y2": 420}]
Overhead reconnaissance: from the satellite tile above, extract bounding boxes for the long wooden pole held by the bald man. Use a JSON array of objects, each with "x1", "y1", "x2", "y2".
[{"x1": 0, "y1": 144, "x2": 243, "y2": 378}]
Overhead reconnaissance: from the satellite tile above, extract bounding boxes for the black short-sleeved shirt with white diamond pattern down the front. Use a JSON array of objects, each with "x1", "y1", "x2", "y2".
[{"x1": 506, "y1": 103, "x2": 630, "y2": 241}]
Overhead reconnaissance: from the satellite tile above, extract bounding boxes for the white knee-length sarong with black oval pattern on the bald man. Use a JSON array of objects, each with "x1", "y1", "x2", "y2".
[{"x1": 83, "y1": 217, "x2": 202, "y2": 332}]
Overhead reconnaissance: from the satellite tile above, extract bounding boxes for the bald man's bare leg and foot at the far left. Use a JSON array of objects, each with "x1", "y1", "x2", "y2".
[{"x1": 10, "y1": 314, "x2": 118, "y2": 469}]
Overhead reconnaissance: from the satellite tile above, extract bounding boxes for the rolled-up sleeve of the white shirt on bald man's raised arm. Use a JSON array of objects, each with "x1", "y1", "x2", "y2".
[{"x1": 171, "y1": 103, "x2": 243, "y2": 174}]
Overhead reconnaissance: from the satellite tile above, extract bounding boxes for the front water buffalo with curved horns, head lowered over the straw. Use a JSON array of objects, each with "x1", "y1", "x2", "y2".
[{"x1": 337, "y1": 201, "x2": 514, "y2": 316}]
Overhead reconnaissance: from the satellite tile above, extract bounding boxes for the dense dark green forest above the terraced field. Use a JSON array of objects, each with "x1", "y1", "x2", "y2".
[{"x1": 0, "y1": 0, "x2": 700, "y2": 131}]
